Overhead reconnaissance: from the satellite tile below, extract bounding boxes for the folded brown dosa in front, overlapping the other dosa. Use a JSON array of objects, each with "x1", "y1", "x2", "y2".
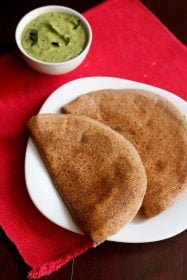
[{"x1": 27, "y1": 114, "x2": 147, "y2": 245}]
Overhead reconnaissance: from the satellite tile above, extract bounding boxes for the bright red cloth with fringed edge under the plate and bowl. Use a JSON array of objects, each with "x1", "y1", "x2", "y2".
[{"x1": 0, "y1": 0, "x2": 187, "y2": 278}]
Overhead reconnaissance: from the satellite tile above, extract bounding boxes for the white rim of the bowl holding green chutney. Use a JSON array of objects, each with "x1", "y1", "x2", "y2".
[{"x1": 15, "y1": 5, "x2": 93, "y2": 66}]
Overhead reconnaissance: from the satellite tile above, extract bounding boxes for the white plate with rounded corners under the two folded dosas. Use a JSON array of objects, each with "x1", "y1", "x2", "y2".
[{"x1": 25, "y1": 77, "x2": 187, "y2": 243}]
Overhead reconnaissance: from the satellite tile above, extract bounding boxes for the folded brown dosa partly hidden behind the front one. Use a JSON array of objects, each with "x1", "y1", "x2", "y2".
[{"x1": 62, "y1": 89, "x2": 187, "y2": 217}]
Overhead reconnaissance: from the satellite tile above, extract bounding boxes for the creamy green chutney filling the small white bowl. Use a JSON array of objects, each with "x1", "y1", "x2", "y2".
[{"x1": 21, "y1": 12, "x2": 87, "y2": 62}]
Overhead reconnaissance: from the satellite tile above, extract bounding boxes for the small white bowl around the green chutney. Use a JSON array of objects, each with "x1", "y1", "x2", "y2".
[{"x1": 15, "y1": 6, "x2": 92, "y2": 75}]
